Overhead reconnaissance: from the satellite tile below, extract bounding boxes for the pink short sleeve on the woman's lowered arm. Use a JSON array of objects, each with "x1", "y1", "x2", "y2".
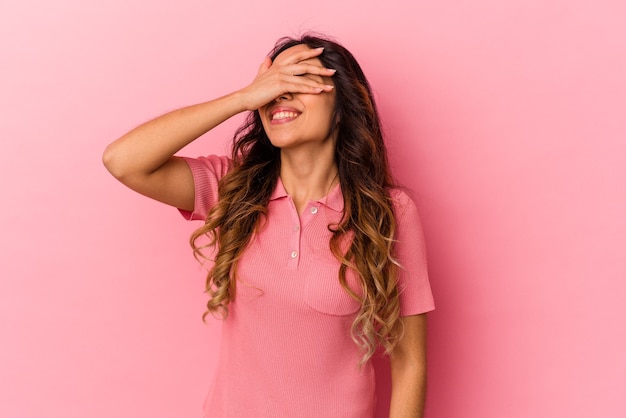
[{"x1": 391, "y1": 190, "x2": 435, "y2": 316}]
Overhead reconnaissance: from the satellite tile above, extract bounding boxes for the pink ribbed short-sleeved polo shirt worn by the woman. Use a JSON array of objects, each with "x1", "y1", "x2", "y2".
[{"x1": 181, "y1": 156, "x2": 434, "y2": 418}]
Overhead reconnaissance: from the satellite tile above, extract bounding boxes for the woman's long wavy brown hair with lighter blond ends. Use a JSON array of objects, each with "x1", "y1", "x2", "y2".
[{"x1": 190, "y1": 34, "x2": 402, "y2": 364}]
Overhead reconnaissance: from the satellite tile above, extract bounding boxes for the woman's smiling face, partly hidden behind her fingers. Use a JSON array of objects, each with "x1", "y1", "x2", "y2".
[{"x1": 259, "y1": 45, "x2": 335, "y2": 150}]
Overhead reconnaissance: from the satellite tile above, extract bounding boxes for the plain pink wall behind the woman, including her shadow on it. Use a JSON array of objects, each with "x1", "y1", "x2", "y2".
[{"x1": 0, "y1": 0, "x2": 626, "y2": 418}]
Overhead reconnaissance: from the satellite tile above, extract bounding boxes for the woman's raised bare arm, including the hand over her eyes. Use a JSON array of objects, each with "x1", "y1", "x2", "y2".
[{"x1": 102, "y1": 49, "x2": 332, "y2": 211}]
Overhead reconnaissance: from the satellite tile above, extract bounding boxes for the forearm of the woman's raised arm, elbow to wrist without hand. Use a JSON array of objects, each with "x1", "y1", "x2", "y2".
[{"x1": 103, "y1": 92, "x2": 246, "y2": 178}]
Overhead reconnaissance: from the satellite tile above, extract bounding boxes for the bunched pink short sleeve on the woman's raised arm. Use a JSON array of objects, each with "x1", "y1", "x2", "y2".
[{"x1": 179, "y1": 155, "x2": 232, "y2": 220}]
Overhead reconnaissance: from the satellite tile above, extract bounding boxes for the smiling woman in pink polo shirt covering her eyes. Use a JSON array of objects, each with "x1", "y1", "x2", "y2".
[{"x1": 103, "y1": 36, "x2": 434, "y2": 418}]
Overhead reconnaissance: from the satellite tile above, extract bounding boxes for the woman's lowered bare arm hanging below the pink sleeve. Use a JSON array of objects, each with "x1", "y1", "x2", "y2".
[{"x1": 389, "y1": 314, "x2": 426, "y2": 418}]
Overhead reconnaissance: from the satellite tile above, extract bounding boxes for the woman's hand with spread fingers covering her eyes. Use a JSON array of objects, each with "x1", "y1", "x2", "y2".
[{"x1": 240, "y1": 48, "x2": 335, "y2": 110}]
